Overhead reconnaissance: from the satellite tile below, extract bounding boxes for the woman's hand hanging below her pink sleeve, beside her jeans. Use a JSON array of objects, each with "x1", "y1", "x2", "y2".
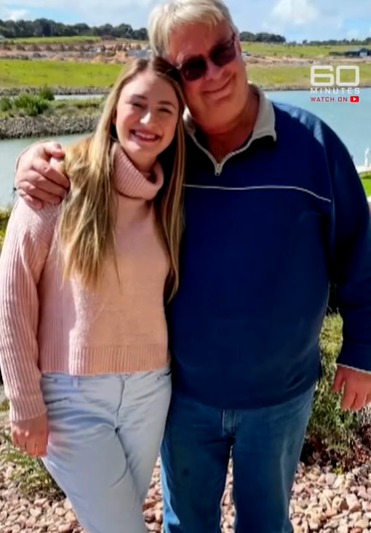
[{"x1": 11, "y1": 413, "x2": 49, "y2": 457}]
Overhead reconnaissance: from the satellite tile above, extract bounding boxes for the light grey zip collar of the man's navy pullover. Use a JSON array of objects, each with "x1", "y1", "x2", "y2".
[{"x1": 184, "y1": 83, "x2": 277, "y2": 176}]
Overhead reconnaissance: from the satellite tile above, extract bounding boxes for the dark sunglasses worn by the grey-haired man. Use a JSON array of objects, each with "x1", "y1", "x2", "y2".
[{"x1": 177, "y1": 35, "x2": 237, "y2": 81}]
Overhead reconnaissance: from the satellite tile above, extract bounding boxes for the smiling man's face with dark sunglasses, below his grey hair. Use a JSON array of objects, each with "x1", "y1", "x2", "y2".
[{"x1": 168, "y1": 22, "x2": 247, "y2": 133}]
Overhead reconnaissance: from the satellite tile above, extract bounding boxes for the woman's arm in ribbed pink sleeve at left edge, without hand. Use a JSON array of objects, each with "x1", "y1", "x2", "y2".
[{"x1": 0, "y1": 200, "x2": 59, "y2": 421}]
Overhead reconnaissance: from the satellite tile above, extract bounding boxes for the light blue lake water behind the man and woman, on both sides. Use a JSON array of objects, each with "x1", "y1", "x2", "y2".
[{"x1": 0, "y1": 88, "x2": 371, "y2": 205}]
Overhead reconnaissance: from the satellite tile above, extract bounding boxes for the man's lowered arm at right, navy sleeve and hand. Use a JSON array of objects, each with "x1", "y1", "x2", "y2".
[{"x1": 326, "y1": 130, "x2": 371, "y2": 409}]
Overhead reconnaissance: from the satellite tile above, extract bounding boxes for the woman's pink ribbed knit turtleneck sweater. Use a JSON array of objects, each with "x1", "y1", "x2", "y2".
[{"x1": 0, "y1": 145, "x2": 169, "y2": 421}]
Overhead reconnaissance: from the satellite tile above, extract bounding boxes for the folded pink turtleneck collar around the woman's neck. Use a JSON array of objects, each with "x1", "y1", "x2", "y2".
[{"x1": 114, "y1": 144, "x2": 164, "y2": 200}]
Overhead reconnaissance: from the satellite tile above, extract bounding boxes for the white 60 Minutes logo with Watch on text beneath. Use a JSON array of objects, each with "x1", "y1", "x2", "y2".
[{"x1": 310, "y1": 65, "x2": 360, "y2": 103}]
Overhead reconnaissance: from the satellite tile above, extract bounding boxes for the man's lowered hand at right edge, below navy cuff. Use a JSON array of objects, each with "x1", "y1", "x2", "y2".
[{"x1": 333, "y1": 365, "x2": 371, "y2": 411}]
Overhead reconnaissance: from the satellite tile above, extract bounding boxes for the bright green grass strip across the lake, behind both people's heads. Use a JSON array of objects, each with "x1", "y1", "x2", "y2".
[{"x1": 0, "y1": 59, "x2": 371, "y2": 88}]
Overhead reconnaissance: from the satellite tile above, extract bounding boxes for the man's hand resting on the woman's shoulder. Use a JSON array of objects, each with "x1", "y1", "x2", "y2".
[{"x1": 15, "y1": 142, "x2": 70, "y2": 209}]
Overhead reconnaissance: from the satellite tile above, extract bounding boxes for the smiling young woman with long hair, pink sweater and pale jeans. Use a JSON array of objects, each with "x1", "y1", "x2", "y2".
[{"x1": 0, "y1": 58, "x2": 185, "y2": 533}]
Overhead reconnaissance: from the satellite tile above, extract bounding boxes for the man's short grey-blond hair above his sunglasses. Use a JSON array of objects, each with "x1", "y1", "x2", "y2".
[{"x1": 148, "y1": 0, "x2": 237, "y2": 57}]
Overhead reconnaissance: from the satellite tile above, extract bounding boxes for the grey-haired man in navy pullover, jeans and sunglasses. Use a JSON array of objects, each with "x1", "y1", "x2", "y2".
[{"x1": 11, "y1": 0, "x2": 371, "y2": 533}]
